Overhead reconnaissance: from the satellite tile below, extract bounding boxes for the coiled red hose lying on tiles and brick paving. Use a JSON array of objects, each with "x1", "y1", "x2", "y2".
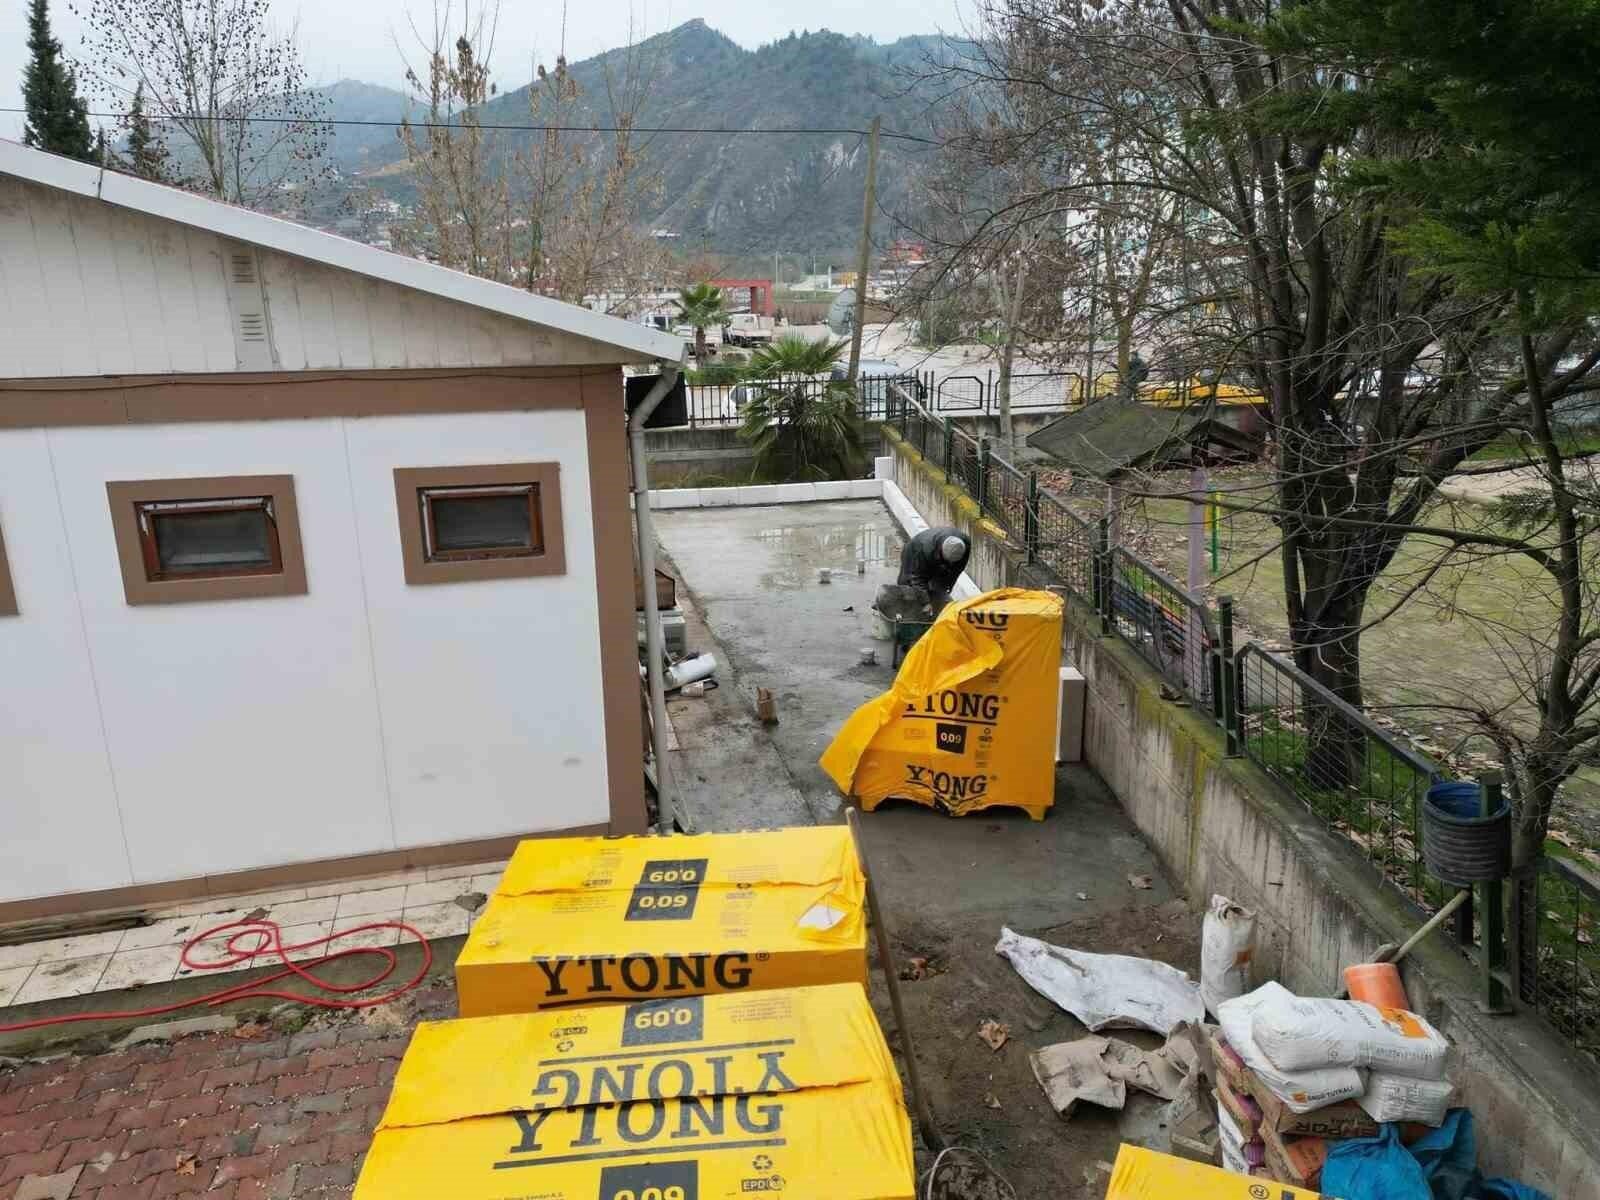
[{"x1": 0, "y1": 918, "x2": 434, "y2": 1034}]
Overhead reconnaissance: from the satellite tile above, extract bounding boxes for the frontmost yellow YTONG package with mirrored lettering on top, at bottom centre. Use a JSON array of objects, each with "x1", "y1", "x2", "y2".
[{"x1": 355, "y1": 984, "x2": 915, "y2": 1200}]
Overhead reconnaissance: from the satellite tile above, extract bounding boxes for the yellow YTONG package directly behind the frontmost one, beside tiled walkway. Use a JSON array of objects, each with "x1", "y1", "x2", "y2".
[{"x1": 456, "y1": 826, "x2": 867, "y2": 1016}]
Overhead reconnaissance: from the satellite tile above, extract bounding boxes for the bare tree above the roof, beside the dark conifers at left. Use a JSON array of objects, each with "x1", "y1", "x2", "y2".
[{"x1": 74, "y1": 0, "x2": 331, "y2": 206}]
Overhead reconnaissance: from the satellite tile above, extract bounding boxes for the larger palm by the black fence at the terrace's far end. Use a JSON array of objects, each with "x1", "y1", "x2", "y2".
[{"x1": 739, "y1": 334, "x2": 866, "y2": 482}]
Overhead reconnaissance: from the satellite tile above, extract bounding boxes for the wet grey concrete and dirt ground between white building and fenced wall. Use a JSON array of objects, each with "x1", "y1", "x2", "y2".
[{"x1": 656, "y1": 501, "x2": 1200, "y2": 1200}]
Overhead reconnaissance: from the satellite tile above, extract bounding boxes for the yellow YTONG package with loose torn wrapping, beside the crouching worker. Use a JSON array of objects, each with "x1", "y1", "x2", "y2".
[{"x1": 822, "y1": 587, "x2": 1061, "y2": 821}]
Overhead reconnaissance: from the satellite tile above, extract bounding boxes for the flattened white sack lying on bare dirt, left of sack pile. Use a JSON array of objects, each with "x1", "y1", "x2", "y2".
[{"x1": 995, "y1": 930, "x2": 1205, "y2": 1037}]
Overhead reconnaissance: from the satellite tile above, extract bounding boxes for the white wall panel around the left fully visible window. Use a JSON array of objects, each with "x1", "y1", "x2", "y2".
[{"x1": 42, "y1": 419, "x2": 394, "y2": 882}]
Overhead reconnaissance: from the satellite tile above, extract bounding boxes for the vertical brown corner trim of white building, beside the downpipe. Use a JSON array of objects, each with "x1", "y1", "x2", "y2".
[{"x1": 584, "y1": 381, "x2": 650, "y2": 834}]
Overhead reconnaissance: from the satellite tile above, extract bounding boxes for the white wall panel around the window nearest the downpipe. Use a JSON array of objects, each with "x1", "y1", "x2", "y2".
[{"x1": 346, "y1": 411, "x2": 608, "y2": 845}]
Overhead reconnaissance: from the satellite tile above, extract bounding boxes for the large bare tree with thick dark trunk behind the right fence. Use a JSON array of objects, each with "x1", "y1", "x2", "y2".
[{"x1": 960, "y1": 0, "x2": 1600, "y2": 800}]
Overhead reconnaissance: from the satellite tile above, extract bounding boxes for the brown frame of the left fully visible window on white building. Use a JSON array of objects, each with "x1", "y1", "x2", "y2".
[{"x1": 106, "y1": 475, "x2": 307, "y2": 605}]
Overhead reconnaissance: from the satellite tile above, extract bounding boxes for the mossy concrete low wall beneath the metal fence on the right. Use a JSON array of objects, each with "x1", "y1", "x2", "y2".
[{"x1": 888, "y1": 437, "x2": 1600, "y2": 1200}]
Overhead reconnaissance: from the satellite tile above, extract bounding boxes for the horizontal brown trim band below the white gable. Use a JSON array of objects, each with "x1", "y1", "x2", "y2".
[{"x1": 0, "y1": 374, "x2": 622, "y2": 429}]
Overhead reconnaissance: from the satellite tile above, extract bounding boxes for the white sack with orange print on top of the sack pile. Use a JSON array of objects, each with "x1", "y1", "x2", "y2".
[{"x1": 1250, "y1": 992, "x2": 1450, "y2": 1078}]
